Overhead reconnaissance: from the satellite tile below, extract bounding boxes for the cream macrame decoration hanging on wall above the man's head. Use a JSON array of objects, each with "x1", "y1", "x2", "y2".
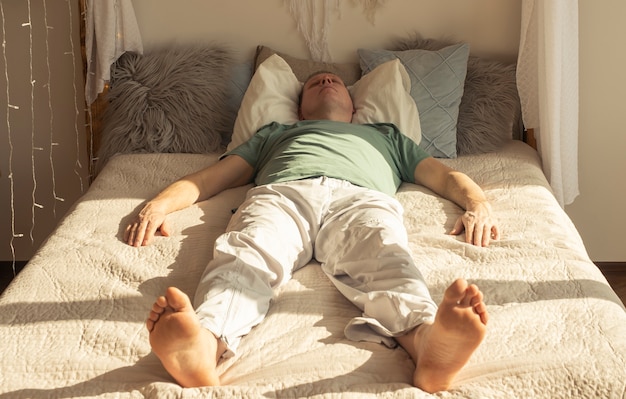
[{"x1": 285, "y1": 0, "x2": 386, "y2": 62}]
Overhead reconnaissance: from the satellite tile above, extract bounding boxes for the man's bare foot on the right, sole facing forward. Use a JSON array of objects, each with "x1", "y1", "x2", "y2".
[{"x1": 396, "y1": 279, "x2": 489, "y2": 393}]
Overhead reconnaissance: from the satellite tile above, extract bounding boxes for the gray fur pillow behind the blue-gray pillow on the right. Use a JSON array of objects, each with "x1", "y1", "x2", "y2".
[{"x1": 392, "y1": 36, "x2": 522, "y2": 155}]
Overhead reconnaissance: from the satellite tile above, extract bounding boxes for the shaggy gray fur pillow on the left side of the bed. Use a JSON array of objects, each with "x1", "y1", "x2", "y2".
[{"x1": 97, "y1": 44, "x2": 236, "y2": 170}]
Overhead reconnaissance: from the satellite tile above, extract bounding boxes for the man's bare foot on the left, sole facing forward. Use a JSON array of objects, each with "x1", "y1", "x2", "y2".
[{"x1": 146, "y1": 287, "x2": 223, "y2": 387}]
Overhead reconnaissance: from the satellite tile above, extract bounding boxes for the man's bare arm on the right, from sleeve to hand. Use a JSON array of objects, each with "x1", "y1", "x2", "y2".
[{"x1": 414, "y1": 158, "x2": 500, "y2": 247}]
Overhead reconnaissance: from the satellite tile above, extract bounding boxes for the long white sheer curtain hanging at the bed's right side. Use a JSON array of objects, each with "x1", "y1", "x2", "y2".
[{"x1": 517, "y1": 0, "x2": 579, "y2": 206}]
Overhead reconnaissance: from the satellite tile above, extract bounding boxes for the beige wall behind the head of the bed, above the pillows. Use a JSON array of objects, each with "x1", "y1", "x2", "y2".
[{"x1": 133, "y1": 0, "x2": 520, "y2": 62}]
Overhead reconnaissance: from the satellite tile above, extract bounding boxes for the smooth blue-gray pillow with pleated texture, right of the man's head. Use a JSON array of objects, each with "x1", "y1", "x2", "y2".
[{"x1": 358, "y1": 43, "x2": 469, "y2": 158}]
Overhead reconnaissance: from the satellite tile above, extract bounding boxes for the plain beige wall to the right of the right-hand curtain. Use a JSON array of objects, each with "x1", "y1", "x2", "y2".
[{"x1": 566, "y1": 0, "x2": 626, "y2": 262}]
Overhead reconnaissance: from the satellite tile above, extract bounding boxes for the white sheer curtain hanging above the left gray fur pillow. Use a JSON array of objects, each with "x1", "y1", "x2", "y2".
[{"x1": 85, "y1": 0, "x2": 143, "y2": 104}]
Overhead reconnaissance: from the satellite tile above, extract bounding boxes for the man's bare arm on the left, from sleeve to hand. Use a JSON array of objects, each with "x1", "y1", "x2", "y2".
[{"x1": 124, "y1": 155, "x2": 254, "y2": 247}]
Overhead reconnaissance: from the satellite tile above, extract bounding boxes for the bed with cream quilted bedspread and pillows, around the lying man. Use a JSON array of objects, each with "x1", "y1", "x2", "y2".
[{"x1": 0, "y1": 39, "x2": 626, "y2": 399}]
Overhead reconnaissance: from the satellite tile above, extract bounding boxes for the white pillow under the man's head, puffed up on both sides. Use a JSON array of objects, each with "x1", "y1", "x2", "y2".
[{"x1": 227, "y1": 54, "x2": 422, "y2": 151}]
